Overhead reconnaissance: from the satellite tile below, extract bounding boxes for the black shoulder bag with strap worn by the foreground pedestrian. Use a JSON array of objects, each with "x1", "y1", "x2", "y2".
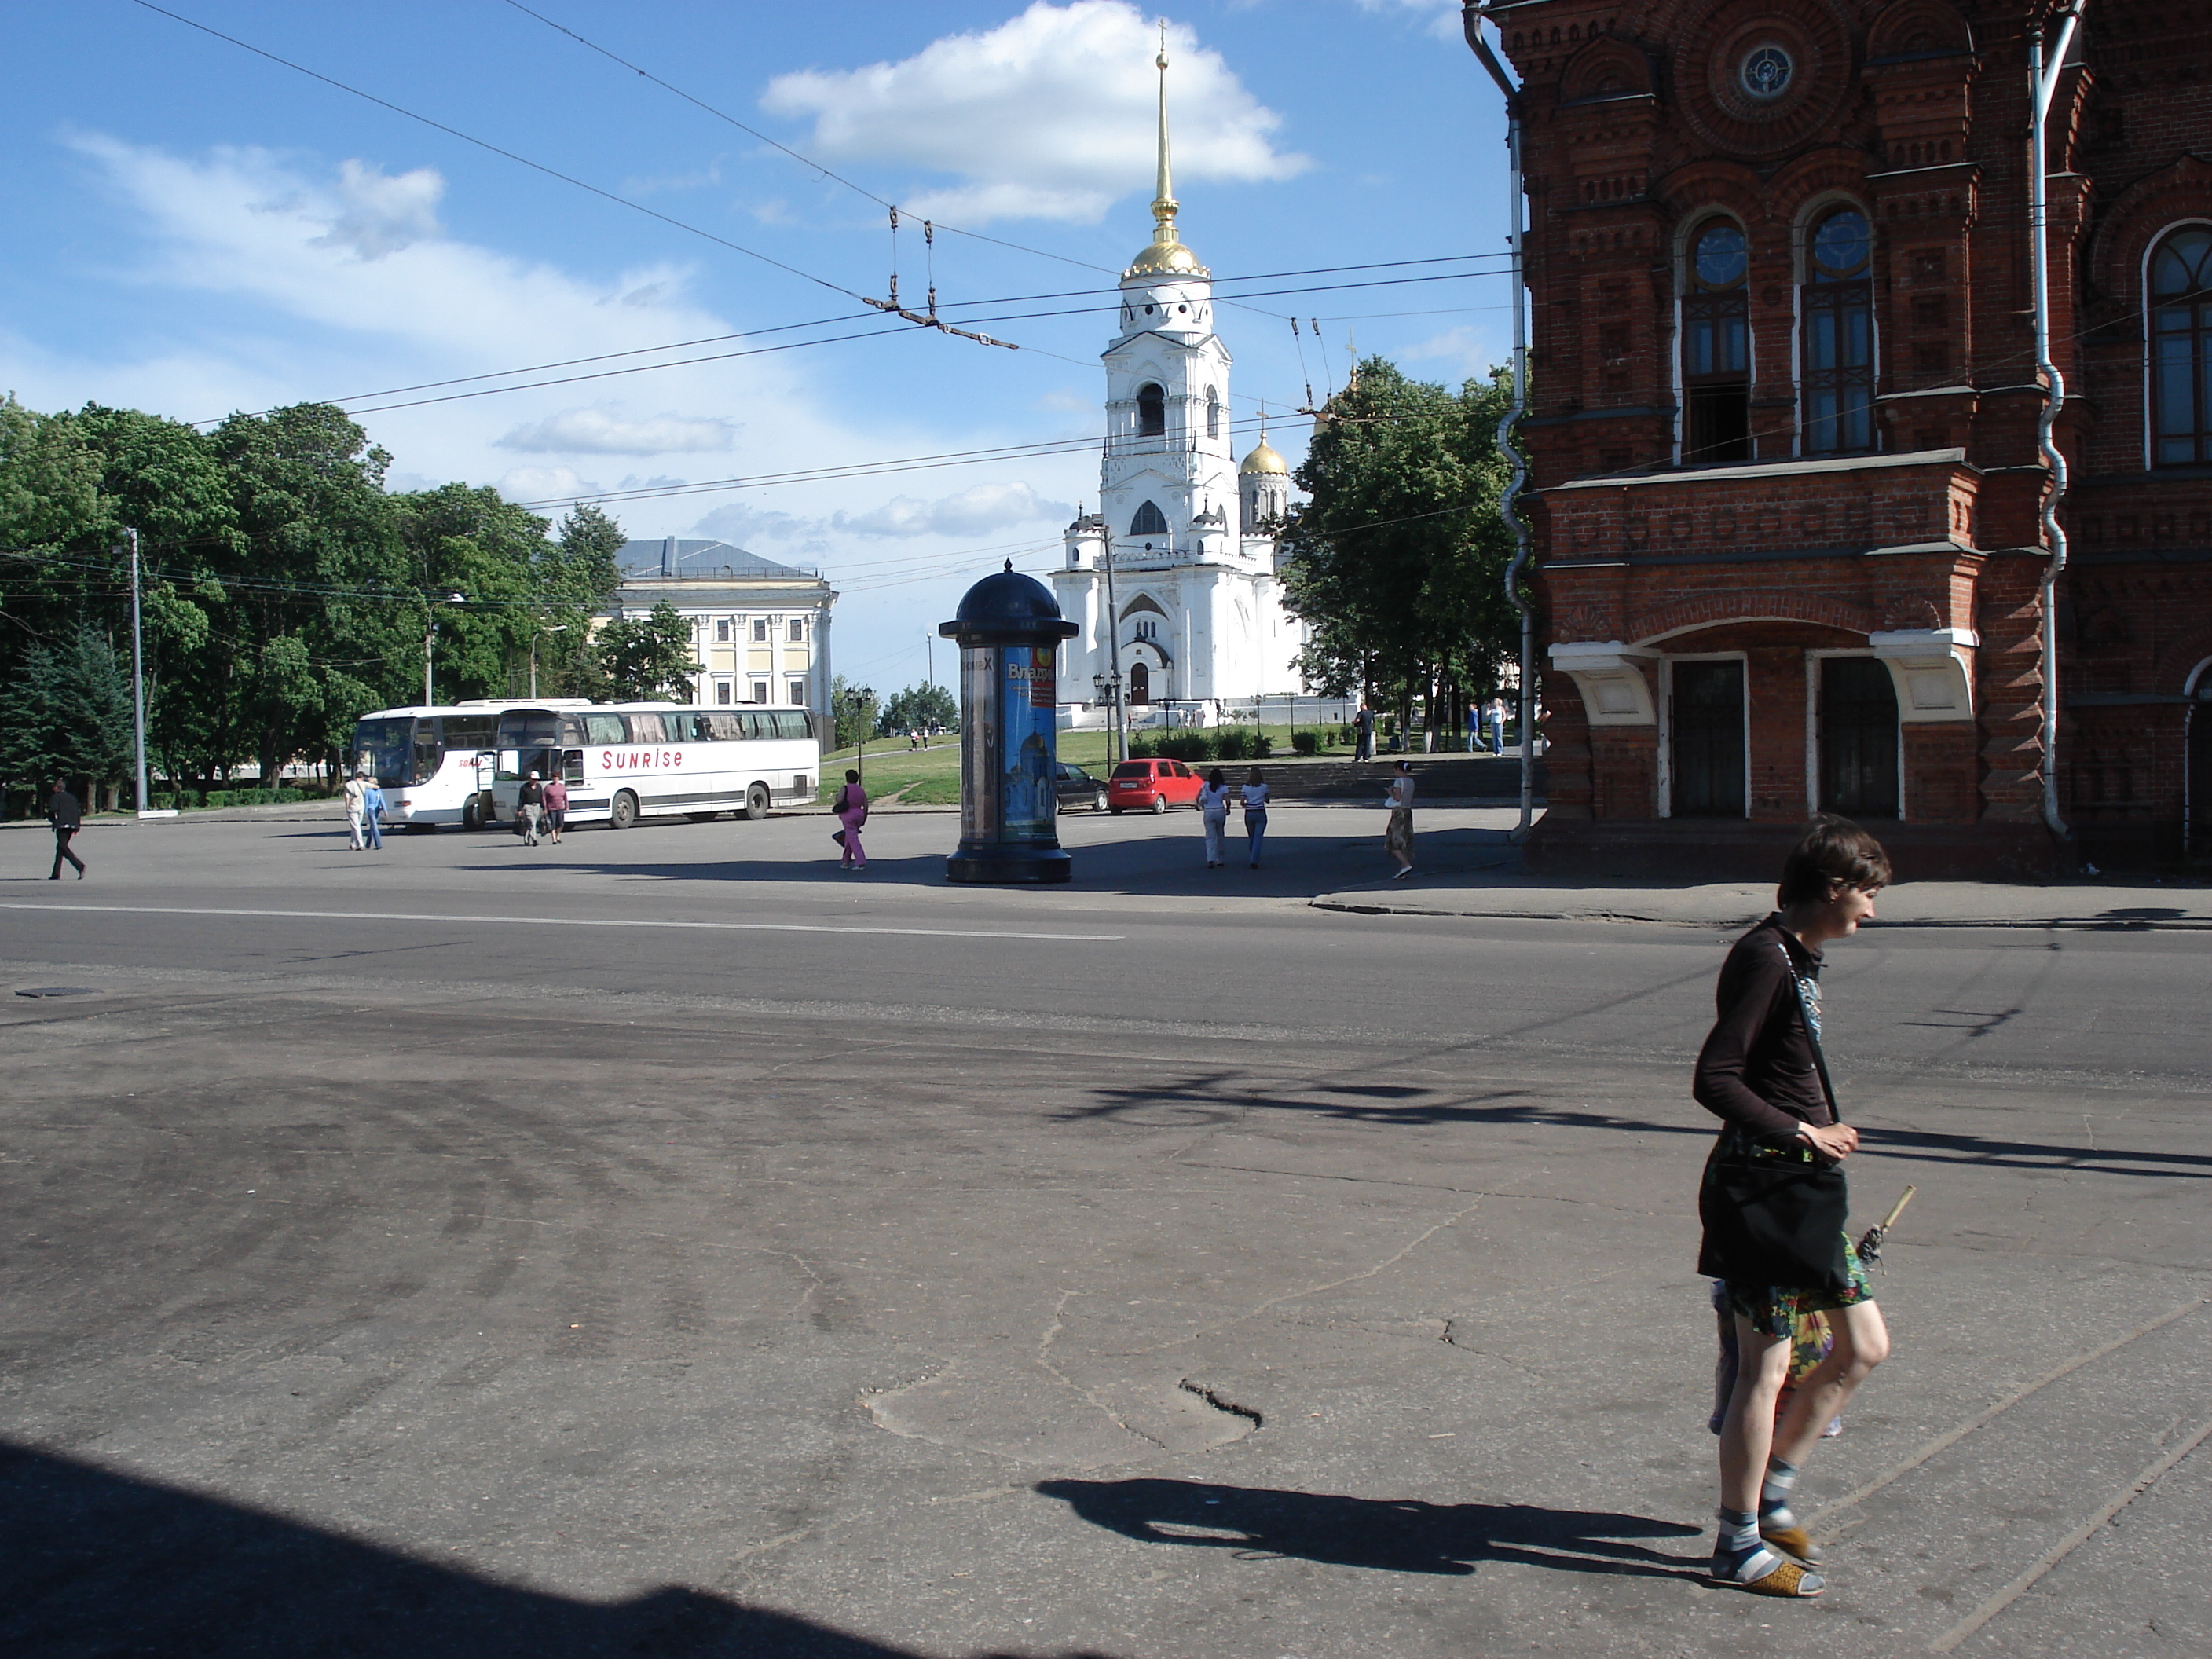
[{"x1": 1697, "y1": 943, "x2": 1851, "y2": 1290}]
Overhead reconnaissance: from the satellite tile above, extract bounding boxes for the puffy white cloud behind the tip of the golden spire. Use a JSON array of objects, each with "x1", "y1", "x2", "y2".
[{"x1": 761, "y1": 0, "x2": 1309, "y2": 225}]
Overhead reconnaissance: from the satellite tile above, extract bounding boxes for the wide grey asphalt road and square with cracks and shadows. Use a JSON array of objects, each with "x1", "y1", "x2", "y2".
[{"x1": 0, "y1": 808, "x2": 2212, "y2": 1659}]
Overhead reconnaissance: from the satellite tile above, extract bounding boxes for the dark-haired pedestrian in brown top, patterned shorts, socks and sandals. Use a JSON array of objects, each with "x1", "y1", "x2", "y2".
[{"x1": 1697, "y1": 816, "x2": 1889, "y2": 1597}]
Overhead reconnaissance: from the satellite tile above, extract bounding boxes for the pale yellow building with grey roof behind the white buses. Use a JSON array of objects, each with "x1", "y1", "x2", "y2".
[{"x1": 610, "y1": 535, "x2": 836, "y2": 710}]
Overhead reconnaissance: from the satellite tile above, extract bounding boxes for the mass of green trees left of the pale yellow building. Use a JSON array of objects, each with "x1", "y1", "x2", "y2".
[{"x1": 0, "y1": 398, "x2": 632, "y2": 800}]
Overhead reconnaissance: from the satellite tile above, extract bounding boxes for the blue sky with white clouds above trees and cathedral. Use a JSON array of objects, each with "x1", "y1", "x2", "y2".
[{"x1": 0, "y1": 0, "x2": 1509, "y2": 690}]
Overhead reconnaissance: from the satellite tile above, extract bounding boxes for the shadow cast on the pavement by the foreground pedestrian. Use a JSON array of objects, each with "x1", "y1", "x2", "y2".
[{"x1": 1038, "y1": 1480, "x2": 1705, "y2": 1577}]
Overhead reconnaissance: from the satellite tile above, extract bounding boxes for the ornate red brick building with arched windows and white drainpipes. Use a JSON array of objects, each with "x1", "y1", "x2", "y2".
[{"x1": 1485, "y1": 0, "x2": 2212, "y2": 876}]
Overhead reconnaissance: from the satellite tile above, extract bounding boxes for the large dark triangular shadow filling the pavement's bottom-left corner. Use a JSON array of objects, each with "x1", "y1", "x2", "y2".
[{"x1": 0, "y1": 1442, "x2": 1104, "y2": 1659}]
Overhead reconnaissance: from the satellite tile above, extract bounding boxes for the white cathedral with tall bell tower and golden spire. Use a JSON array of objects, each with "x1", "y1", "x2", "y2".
[{"x1": 1053, "y1": 53, "x2": 1305, "y2": 723}]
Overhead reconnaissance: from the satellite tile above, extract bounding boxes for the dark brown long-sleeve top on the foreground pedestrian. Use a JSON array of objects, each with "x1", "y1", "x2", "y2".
[{"x1": 1692, "y1": 916, "x2": 1836, "y2": 1141}]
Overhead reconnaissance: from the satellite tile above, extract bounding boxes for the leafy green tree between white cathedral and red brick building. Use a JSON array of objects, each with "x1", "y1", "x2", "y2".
[{"x1": 1283, "y1": 358, "x2": 1520, "y2": 738}]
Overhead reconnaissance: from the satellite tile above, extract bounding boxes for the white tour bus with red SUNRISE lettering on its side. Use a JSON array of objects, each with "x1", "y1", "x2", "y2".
[{"x1": 491, "y1": 703, "x2": 823, "y2": 830}]
